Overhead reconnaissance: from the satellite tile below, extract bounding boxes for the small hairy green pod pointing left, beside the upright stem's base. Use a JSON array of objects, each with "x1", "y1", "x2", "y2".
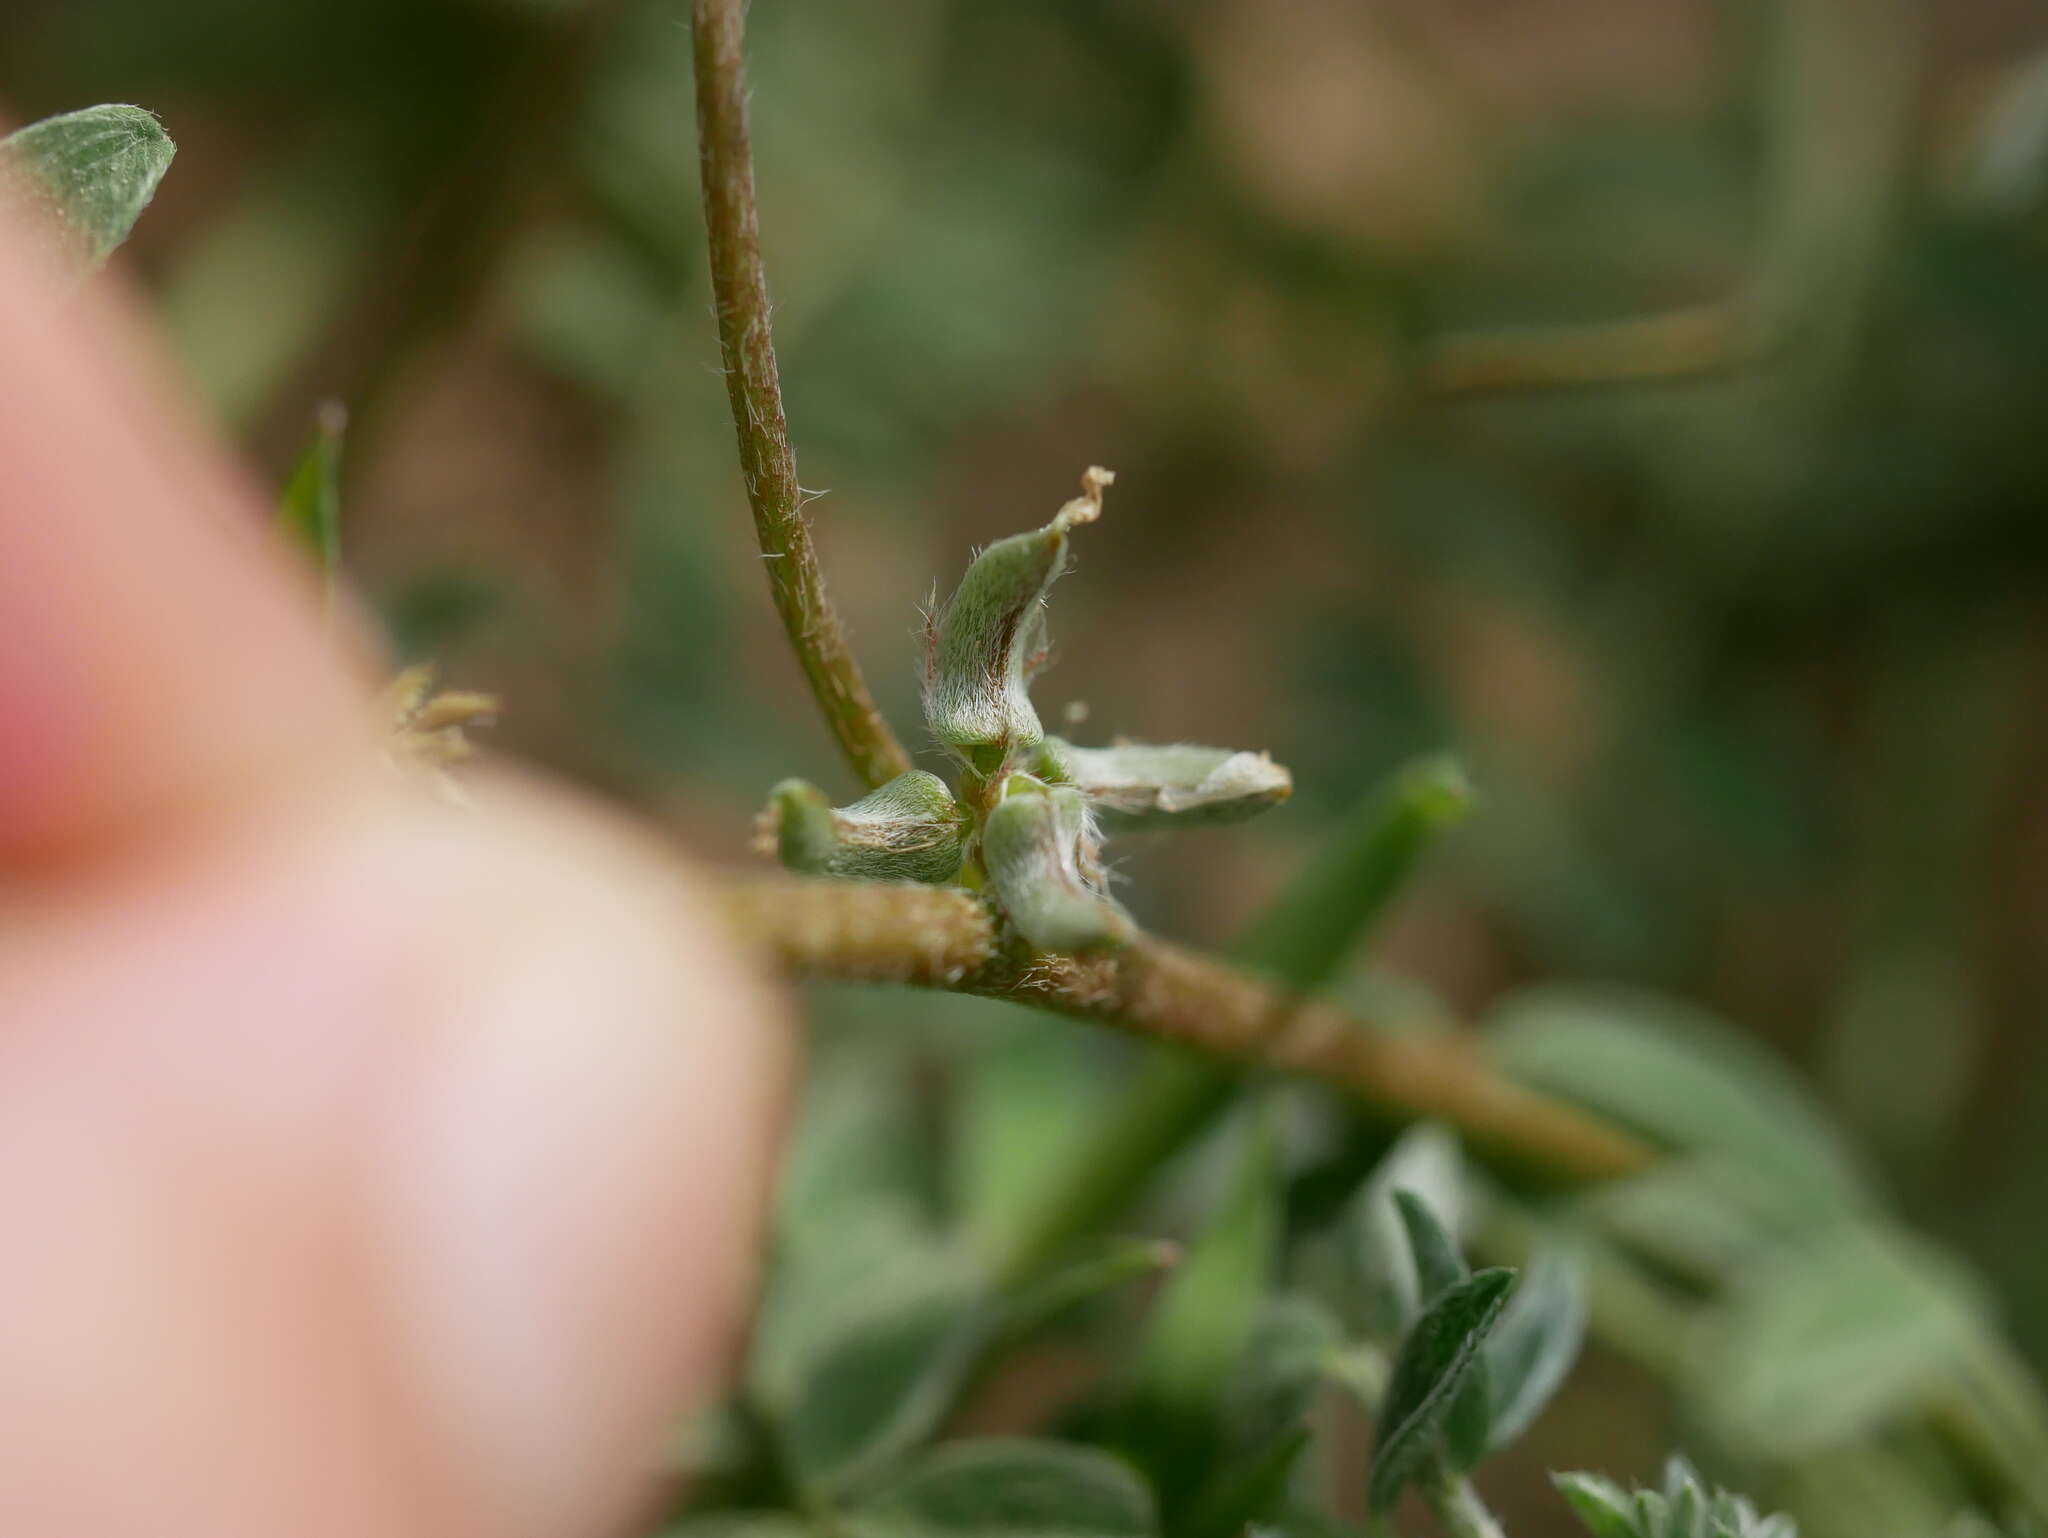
[{"x1": 762, "y1": 770, "x2": 967, "y2": 885}]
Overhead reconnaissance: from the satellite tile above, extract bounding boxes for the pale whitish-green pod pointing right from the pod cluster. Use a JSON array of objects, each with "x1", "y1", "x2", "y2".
[{"x1": 1034, "y1": 737, "x2": 1294, "y2": 834}]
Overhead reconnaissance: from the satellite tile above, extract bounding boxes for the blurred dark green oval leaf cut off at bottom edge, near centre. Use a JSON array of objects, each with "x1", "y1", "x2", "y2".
[{"x1": 850, "y1": 1440, "x2": 1159, "y2": 1538}]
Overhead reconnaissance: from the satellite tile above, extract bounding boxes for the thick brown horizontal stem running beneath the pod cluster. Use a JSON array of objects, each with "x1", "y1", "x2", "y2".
[{"x1": 725, "y1": 877, "x2": 1655, "y2": 1182}]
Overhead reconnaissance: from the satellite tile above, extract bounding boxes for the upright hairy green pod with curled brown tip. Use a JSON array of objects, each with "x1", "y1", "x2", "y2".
[{"x1": 924, "y1": 469, "x2": 1114, "y2": 776}]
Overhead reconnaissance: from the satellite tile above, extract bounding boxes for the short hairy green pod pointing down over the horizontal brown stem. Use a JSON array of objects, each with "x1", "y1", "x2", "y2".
[{"x1": 981, "y1": 774, "x2": 1137, "y2": 950}]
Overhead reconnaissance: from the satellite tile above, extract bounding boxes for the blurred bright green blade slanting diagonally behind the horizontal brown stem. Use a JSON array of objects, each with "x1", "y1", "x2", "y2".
[{"x1": 995, "y1": 758, "x2": 1470, "y2": 1284}]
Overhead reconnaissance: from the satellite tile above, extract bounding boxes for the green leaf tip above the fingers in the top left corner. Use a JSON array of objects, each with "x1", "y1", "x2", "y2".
[{"x1": 0, "y1": 106, "x2": 178, "y2": 274}]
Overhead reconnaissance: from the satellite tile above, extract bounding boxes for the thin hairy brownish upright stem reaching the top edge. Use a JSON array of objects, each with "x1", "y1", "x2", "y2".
[{"x1": 692, "y1": 0, "x2": 909, "y2": 788}]
